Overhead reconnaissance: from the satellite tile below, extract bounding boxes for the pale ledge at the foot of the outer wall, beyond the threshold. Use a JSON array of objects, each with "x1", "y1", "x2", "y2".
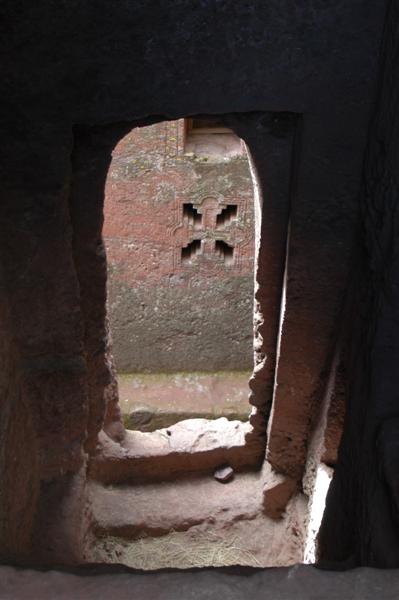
[{"x1": 118, "y1": 371, "x2": 251, "y2": 431}]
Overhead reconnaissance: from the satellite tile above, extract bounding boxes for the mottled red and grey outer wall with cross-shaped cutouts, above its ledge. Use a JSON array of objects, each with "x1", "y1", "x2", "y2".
[{"x1": 104, "y1": 119, "x2": 254, "y2": 372}]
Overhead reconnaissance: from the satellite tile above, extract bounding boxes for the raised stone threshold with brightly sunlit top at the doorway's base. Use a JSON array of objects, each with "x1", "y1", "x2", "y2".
[{"x1": 88, "y1": 417, "x2": 265, "y2": 485}]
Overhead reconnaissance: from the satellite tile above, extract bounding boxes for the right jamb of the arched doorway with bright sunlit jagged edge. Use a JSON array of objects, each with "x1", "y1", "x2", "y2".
[{"x1": 227, "y1": 113, "x2": 297, "y2": 446}]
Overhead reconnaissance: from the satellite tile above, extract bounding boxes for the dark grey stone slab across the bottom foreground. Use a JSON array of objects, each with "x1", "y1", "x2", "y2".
[{"x1": 0, "y1": 565, "x2": 399, "y2": 600}]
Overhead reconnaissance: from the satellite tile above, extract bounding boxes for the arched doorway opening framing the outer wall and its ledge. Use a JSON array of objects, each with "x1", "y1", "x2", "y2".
[{"x1": 104, "y1": 116, "x2": 255, "y2": 432}]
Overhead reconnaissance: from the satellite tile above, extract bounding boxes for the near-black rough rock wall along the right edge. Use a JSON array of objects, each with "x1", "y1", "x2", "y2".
[{"x1": 319, "y1": 2, "x2": 399, "y2": 567}]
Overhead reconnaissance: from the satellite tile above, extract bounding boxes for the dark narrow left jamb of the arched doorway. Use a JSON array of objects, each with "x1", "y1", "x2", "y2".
[{"x1": 70, "y1": 126, "x2": 125, "y2": 452}]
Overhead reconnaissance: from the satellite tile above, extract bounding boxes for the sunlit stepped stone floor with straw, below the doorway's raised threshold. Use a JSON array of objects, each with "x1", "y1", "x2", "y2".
[{"x1": 86, "y1": 471, "x2": 307, "y2": 570}]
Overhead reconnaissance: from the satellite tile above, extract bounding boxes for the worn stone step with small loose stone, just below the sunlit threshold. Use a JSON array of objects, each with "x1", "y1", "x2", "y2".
[{"x1": 89, "y1": 473, "x2": 262, "y2": 539}]
